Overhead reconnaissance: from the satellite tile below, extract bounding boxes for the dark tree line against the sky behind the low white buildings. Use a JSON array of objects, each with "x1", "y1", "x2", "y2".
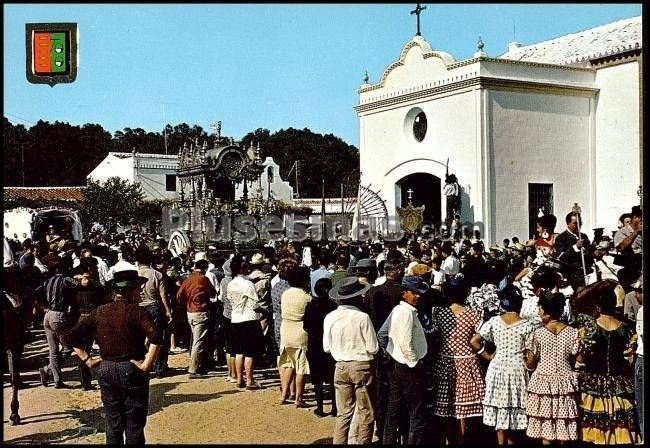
[{"x1": 3, "y1": 117, "x2": 359, "y2": 198}]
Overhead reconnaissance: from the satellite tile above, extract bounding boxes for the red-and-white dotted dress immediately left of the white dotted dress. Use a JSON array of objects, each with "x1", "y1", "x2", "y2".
[{"x1": 433, "y1": 307, "x2": 485, "y2": 419}]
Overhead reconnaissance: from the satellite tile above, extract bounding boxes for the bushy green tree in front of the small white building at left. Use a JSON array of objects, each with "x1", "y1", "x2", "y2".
[{"x1": 80, "y1": 177, "x2": 144, "y2": 228}]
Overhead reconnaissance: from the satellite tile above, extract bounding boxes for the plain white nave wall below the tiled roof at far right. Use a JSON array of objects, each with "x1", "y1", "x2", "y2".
[{"x1": 596, "y1": 61, "x2": 642, "y2": 229}]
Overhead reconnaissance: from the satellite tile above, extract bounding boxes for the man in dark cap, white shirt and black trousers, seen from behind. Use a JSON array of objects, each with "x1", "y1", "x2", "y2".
[{"x1": 379, "y1": 276, "x2": 429, "y2": 445}]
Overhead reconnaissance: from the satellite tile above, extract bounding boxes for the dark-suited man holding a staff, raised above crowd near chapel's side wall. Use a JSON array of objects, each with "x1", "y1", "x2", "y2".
[{"x1": 555, "y1": 212, "x2": 593, "y2": 290}]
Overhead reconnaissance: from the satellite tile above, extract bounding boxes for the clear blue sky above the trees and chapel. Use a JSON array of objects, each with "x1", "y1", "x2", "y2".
[{"x1": 3, "y1": 3, "x2": 642, "y2": 147}]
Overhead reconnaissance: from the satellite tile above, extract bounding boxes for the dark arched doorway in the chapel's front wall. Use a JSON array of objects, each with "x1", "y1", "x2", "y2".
[{"x1": 395, "y1": 173, "x2": 442, "y2": 225}]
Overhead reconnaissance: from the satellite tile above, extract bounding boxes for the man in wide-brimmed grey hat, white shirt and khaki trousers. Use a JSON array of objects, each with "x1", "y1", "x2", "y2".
[{"x1": 323, "y1": 277, "x2": 379, "y2": 444}]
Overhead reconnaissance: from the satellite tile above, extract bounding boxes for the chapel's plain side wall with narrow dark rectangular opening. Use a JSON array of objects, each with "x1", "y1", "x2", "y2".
[{"x1": 488, "y1": 90, "x2": 593, "y2": 241}]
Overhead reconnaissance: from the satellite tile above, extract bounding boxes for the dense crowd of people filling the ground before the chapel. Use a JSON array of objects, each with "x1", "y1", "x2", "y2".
[{"x1": 3, "y1": 207, "x2": 643, "y2": 445}]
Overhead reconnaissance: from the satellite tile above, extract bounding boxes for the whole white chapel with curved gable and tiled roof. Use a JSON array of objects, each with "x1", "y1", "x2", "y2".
[{"x1": 355, "y1": 17, "x2": 643, "y2": 243}]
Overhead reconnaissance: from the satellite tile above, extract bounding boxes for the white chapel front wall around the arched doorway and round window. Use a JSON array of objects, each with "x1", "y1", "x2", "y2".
[{"x1": 360, "y1": 90, "x2": 482, "y2": 228}]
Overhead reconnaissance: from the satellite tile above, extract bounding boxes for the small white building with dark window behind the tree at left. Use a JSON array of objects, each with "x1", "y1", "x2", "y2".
[{"x1": 88, "y1": 152, "x2": 178, "y2": 199}]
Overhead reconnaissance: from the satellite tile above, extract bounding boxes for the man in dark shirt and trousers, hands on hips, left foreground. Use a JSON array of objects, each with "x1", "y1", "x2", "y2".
[{"x1": 63, "y1": 261, "x2": 162, "y2": 445}]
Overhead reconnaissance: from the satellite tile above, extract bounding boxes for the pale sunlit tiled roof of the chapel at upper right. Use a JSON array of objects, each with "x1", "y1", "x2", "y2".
[{"x1": 499, "y1": 16, "x2": 643, "y2": 65}]
